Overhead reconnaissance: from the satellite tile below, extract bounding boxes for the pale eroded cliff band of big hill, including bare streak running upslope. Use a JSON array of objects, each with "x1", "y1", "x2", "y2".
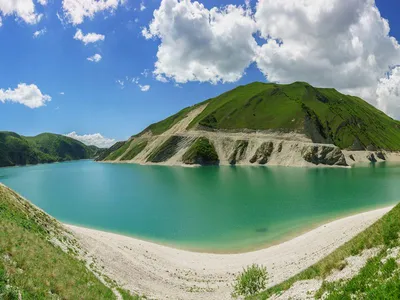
[{"x1": 101, "y1": 105, "x2": 396, "y2": 167}]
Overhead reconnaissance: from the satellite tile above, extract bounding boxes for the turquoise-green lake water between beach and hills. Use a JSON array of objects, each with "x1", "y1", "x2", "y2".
[{"x1": 0, "y1": 161, "x2": 400, "y2": 251}]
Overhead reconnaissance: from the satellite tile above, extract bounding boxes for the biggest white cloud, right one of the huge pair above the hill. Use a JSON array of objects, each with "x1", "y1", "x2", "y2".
[{"x1": 255, "y1": 0, "x2": 400, "y2": 103}]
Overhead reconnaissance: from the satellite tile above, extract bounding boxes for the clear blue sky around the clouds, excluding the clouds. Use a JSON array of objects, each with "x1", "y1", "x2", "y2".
[{"x1": 0, "y1": 0, "x2": 400, "y2": 146}]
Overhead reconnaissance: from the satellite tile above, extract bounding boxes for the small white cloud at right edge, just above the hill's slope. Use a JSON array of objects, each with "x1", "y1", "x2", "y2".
[{"x1": 376, "y1": 67, "x2": 400, "y2": 117}]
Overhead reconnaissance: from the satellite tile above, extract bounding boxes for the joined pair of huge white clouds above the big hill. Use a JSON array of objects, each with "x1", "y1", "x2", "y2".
[{"x1": 142, "y1": 0, "x2": 400, "y2": 117}]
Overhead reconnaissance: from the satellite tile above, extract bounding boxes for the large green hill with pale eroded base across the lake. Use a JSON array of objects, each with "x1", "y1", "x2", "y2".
[{"x1": 98, "y1": 82, "x2": 400, "y2": 164}]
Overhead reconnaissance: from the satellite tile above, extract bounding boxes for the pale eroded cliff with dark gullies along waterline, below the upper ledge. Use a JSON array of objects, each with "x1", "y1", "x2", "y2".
[{"x1": 108, "y1": 132, "x2": 347, "y2": 166}]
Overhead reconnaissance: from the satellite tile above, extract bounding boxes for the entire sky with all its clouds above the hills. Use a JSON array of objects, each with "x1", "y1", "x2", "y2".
[{"x1": 0, "y1": 0, "x2": 400, "y2": 147}]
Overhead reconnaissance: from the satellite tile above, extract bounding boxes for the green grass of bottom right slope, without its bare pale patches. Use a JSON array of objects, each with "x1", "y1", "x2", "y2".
[{"x1": 251, "y1": 204, "x2": 400, "y2": 299}]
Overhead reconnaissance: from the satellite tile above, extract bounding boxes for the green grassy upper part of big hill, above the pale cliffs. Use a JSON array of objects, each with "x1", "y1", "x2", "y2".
[{"x1": 139, "y1": 82, "x2": 400, "y2": 150}]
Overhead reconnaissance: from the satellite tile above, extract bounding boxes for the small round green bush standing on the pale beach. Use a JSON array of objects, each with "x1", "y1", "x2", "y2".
[{"x1": 232, "y1": 264, "x2": 268, "y2": 298}]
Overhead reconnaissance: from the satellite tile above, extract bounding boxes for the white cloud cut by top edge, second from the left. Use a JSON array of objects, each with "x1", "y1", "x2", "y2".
[{"x1": 62, "y1": 0, "x2": 125, "y2": 25}]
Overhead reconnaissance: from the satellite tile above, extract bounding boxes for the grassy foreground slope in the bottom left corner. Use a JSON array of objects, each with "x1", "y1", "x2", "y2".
[{"x1": 0, "y1": 184, "x2": 138, "y2": 299}]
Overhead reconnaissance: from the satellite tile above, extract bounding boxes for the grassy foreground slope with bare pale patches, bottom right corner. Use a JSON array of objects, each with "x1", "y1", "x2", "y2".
[{"x1": 253, "y1": 204, "x2": 400, "y2": 300}]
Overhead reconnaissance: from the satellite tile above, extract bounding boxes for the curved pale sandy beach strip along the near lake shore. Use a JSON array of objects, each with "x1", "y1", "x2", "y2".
[{"x1": 65, "y1": 206, "x2": 393, "y2": 300}]
